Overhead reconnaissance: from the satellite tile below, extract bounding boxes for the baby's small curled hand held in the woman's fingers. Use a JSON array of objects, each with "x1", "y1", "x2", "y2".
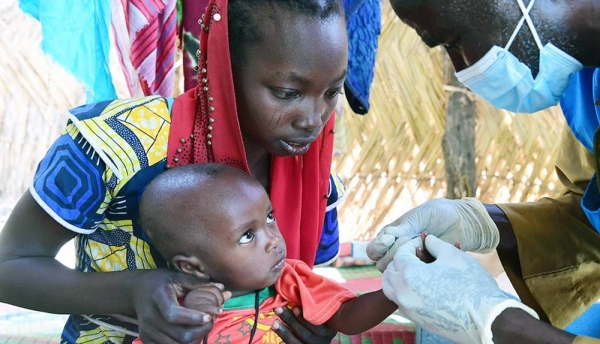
[{"x1": 183, "y1": 283, "x2": 231, "y2": 322}]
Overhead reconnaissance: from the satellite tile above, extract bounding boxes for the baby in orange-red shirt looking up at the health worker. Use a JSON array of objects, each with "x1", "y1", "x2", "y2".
[{"x1": 140, "y1": 164, "x2": 397, "y2": 343}]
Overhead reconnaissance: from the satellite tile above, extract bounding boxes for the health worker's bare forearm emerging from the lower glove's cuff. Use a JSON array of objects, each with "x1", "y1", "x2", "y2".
[{"x1": 492, "y1": 308, "x2": 575, "y2": 344}]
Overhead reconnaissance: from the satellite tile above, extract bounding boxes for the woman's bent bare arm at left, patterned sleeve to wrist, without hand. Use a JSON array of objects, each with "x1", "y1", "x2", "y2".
[{"x1": 0, "y1": 192, "x2": 136, "y2": 314}]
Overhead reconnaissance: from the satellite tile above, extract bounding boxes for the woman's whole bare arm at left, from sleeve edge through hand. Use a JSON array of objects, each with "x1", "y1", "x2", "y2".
[{"x1": 0, "y1": 191, "x2": 223, "y2": 344}]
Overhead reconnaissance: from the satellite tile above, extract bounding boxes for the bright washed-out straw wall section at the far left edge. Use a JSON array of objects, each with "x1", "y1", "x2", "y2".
[{"x1": 0, "y1": 0, "x2": 83, "y2": 218}]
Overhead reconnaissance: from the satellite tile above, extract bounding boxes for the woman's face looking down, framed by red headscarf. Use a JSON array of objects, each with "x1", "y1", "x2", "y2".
[{"x1": 234, "y1": 11, "x2": 348, "y2": 156}]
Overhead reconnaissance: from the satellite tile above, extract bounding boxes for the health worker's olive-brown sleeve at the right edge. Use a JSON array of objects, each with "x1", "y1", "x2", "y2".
[{"x1": 488, "y1": 192, "x2": 600, "y2": 328}]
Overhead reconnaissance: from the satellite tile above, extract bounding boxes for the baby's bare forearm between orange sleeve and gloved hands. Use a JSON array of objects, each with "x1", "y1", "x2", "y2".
[{"x1": 327, "y1": 290, "x2": 398, "y2": 335}]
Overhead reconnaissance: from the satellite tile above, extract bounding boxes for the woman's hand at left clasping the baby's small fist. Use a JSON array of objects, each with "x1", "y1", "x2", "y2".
[{"x1": 133, "y1": 269, "x2": 230, "y2": 344}]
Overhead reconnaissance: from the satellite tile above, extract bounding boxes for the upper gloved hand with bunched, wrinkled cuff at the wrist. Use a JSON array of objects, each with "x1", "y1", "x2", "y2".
[{"x1": 367, "y1": 197, "x2": 500, "y2": 272}]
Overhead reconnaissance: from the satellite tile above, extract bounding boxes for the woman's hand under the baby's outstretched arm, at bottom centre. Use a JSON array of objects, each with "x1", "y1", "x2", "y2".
[{"x1": 273, "y1": 307, "x2": 337, "y2": 344}]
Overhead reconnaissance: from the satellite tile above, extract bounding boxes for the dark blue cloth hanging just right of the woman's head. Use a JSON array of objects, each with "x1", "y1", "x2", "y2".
[{"x1": 344, "y1": 0, "x2": 381, "y2": 115}]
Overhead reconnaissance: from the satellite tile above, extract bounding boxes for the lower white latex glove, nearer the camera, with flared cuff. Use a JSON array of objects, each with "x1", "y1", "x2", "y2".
[{"x1": 383, "y1": 235, "x2": 539, "y2": 343}]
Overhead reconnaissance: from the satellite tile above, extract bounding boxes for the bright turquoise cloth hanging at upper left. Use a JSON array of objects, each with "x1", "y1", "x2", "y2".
[{"x1": 19, "y1": 0, "x2": 117, "y2": 103}]
